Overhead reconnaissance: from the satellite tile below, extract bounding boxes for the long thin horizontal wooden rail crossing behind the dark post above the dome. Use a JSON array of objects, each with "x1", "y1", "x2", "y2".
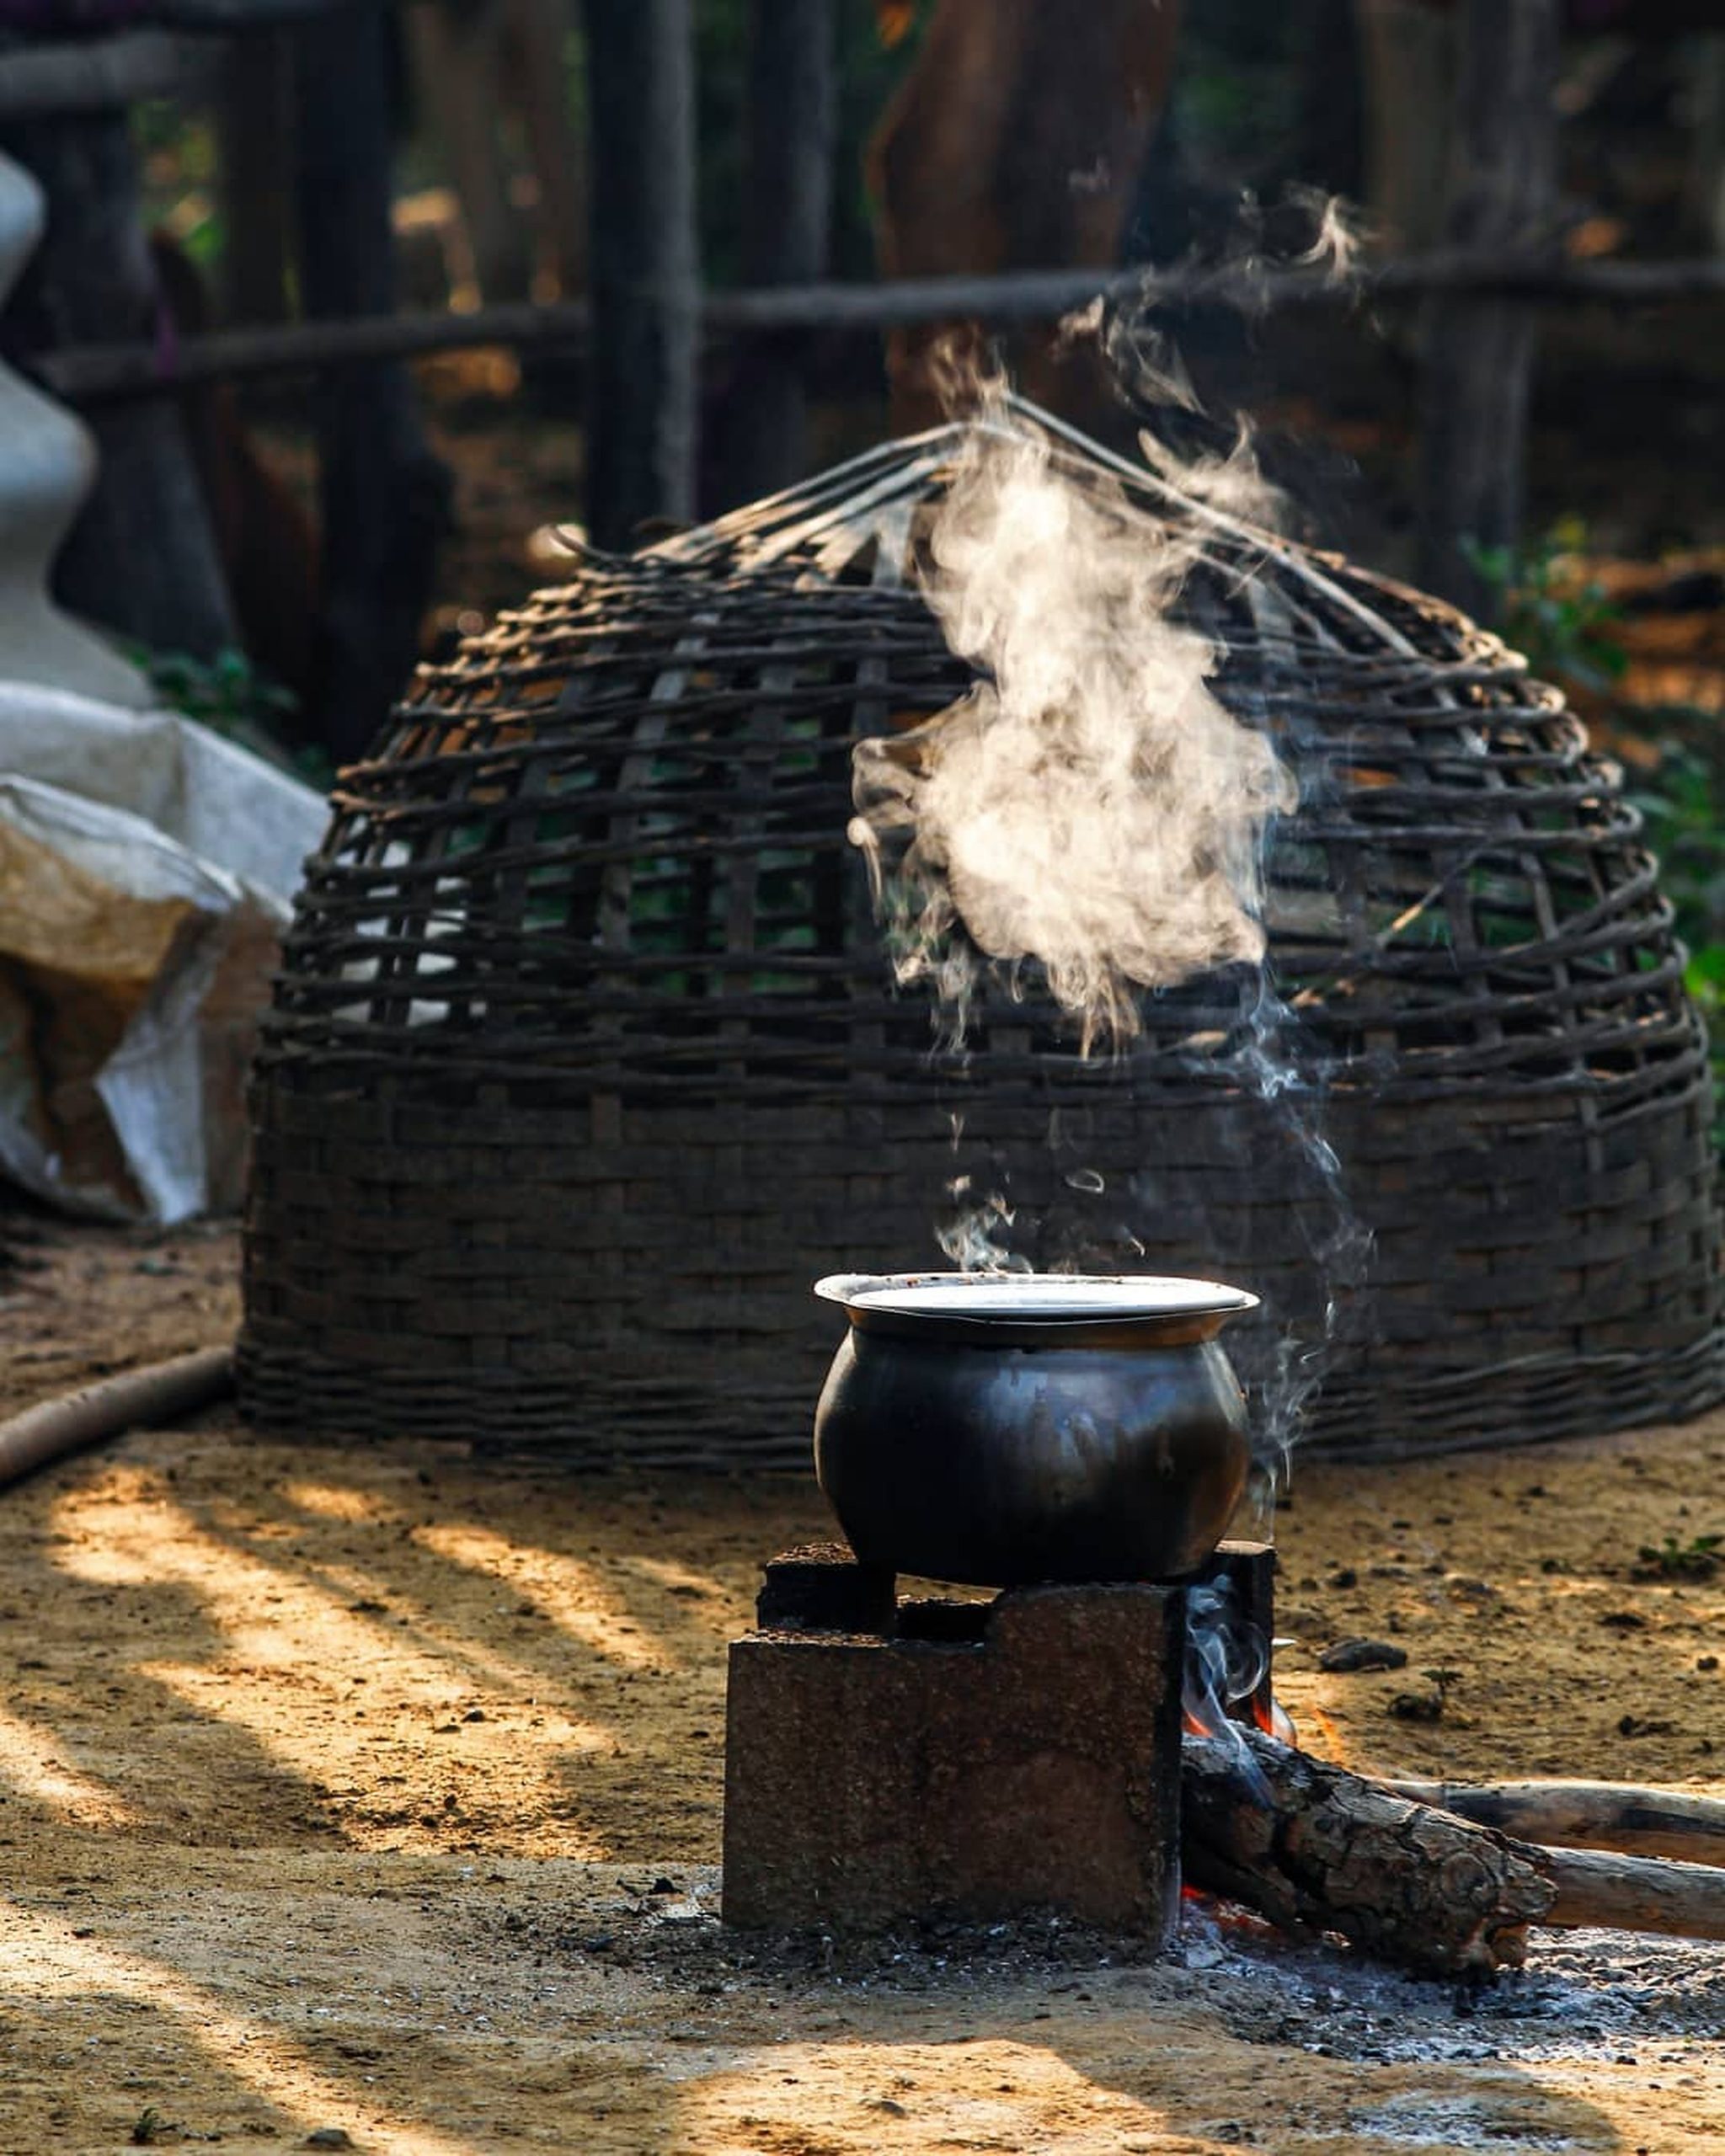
[{"x1": 35, "y1": 254, "x2": 1725, "y2": 403}]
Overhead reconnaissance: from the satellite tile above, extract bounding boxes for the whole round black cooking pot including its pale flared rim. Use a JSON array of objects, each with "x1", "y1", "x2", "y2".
[{"x1": 815, "y1": 1272, "x2": 1257, "y2": 1587}]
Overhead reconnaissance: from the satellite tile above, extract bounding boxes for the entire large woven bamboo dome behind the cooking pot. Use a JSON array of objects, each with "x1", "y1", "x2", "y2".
[{"x1": 239, "y1": 408, "x2": 1725, "y2": 1464}]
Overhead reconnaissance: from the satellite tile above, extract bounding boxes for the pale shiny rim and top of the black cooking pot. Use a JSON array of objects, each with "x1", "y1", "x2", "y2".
[{"x1": 815, "y1": 1272, "x2": 1259, "y2": 1348}]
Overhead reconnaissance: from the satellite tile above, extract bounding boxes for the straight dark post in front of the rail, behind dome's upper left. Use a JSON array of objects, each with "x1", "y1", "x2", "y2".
[{"x1": 585, "y1": 0, "x2": 701, "y2": 550}]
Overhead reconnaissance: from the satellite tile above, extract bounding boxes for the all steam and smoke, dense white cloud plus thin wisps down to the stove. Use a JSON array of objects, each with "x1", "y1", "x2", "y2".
[{"x1": 850, "y1": 244, "x2": 1371, "y2": 1540}]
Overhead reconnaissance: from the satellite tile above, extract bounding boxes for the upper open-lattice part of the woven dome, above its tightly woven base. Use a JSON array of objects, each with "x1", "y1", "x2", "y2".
[{"x1": 263, "y1": 405, "x2": 1703, "y2": 1117}]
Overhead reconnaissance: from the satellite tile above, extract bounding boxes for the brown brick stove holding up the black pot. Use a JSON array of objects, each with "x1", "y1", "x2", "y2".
[{"x1": 723, "y1": 1544, "x2": 1274, "y2": 1940}]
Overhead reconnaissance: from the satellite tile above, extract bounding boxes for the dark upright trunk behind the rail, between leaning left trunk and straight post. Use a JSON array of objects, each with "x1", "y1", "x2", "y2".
[{"x1": 296, "y1": 4, "x2": 451, "y2": 759}]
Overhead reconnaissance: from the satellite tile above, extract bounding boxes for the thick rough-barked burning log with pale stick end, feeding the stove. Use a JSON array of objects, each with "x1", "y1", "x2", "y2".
[{"x1": 1182, "y1": 1725, "x2": 1725, "y2": 1975}]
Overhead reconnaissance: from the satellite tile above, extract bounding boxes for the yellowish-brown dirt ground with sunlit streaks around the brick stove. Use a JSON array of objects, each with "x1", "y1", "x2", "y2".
[{"x1": 0, "y1": 1220, "x2": 1725, "y2": 2156}]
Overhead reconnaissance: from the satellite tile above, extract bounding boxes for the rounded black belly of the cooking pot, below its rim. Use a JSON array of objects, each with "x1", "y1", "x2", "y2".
[{"x1": 815, "y1": 1331, "x2": 1248, "y2": 1587}]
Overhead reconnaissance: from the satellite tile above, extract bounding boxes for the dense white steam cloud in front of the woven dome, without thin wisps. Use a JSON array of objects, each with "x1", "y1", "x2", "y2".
[{"x1": 850, "y1": 390, "x2": 1296, "y2": 1052}]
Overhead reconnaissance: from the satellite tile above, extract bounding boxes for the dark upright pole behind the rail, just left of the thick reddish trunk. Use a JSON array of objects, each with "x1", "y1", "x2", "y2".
[{"x1": 716, "y1": 0, "x2": 836, "y2": 507}]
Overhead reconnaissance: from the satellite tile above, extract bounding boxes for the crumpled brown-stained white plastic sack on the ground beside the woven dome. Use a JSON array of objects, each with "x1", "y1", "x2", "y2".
[{"x1": 0, "y1": 684, "x2": 326, "y2": 1225}]
